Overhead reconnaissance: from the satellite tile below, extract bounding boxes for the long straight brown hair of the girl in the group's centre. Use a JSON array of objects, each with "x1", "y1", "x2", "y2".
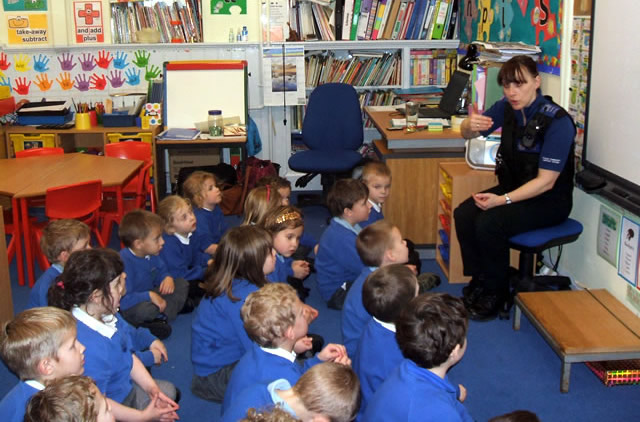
[{"x1": 205, "y1": 225, "x2": 273, "y2": 302}]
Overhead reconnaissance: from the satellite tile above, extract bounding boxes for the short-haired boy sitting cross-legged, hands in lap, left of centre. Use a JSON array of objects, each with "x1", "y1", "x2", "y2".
[{"x1": 118, "y1": 209, "x2": 189, "y2": 338}]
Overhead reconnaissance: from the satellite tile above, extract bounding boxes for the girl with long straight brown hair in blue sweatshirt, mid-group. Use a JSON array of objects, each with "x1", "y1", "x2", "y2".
[{"x1": 191, "y1": 225, "x2": 276, "y2": 402}]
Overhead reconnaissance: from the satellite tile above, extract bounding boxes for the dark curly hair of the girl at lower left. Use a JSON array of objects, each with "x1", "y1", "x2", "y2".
[{"x1": 48, "y1": 249, "x2": 124, "y2": 312}]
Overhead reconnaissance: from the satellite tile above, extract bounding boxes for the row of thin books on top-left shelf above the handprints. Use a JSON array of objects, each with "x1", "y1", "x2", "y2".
[{"x1": 111, "y1": 0, "x2": 203, "y2": 44}]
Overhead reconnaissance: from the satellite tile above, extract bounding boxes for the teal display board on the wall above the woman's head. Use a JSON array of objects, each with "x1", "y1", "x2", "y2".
[{"x1": 459, "y1": 0, "x2": 563, "y2": 75}]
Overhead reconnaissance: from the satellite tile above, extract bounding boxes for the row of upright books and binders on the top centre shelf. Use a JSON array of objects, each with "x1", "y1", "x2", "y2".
[{"x1": 289, "y1": 0, "x2": 460, "y2": 41}]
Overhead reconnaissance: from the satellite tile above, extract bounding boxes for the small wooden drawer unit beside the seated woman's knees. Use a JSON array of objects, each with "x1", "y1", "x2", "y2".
[{"x1": 435, "y1": 162, "x2": 498, "y2": 283}]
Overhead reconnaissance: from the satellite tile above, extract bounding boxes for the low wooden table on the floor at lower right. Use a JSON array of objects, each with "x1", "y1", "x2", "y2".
[{"x1": 513, "y1": 289, "x2": 640, "y2": 393}]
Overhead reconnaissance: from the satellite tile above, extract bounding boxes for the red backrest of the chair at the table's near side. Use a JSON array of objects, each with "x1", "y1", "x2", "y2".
[{"x1": 44, "y1": 180, "x2": 102, "y2": 219}]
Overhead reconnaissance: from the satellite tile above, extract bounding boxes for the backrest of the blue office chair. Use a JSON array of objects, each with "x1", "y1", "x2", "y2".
[{"x1": 302, "y1": 83, "x2": 364, "y2": 151}]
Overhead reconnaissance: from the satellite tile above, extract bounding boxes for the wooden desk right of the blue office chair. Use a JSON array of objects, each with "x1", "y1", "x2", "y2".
[{"x1": 365, "y1": 107, "x2": 464, "y2": 247}]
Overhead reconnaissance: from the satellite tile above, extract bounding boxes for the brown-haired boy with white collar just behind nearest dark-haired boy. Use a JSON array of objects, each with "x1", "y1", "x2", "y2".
[{"x1": 353, "y1": 266, "x2": 418, "y2": 413}]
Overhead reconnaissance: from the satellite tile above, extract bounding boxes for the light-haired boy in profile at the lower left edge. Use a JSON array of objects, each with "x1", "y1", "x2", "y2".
[{"x1": 0, "y1": 307, "x2": 85, "y2": 422}]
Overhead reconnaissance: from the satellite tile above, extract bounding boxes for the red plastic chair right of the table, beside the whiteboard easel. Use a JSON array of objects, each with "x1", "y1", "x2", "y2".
[{"x1": 102, "y1": 141, "x2": 157, "y2": 241}]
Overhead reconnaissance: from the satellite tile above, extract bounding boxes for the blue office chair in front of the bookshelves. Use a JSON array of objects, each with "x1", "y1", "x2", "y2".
[{"x1": 289, "y1": 83, "x2": 363, "y2": 200}]
